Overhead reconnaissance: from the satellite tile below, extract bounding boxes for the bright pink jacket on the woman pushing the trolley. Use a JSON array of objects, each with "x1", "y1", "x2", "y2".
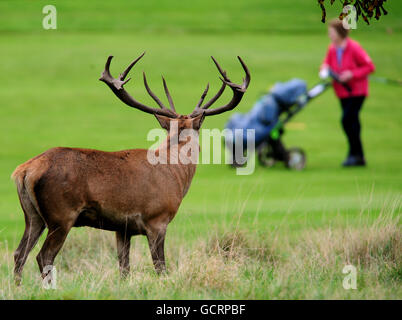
[{"x1": 322, "y1": 38, "x2": 375, "y2": 98}]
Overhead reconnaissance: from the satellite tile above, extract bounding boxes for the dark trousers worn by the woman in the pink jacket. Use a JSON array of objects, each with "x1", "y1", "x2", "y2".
[{"x1": 341, "y1": 96, "x2": 365, "y2": 157}]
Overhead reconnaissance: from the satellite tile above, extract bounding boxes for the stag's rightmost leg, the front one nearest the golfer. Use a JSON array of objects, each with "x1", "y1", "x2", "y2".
[{"x1": 147, "y1": 226, "x2": 166, "y2": 273}]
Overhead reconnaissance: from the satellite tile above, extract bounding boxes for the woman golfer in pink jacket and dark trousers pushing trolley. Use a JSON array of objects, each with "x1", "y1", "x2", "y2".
[{"x1": 321, "y1": 19, "x2": 375, "y2": 167}]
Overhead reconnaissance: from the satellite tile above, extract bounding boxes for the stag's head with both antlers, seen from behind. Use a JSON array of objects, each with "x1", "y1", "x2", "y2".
[{"x1": 99, "y1": 52, "x2": 250, "y2": 134}]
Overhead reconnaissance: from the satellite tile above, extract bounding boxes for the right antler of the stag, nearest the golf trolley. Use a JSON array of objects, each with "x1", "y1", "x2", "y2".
[{"x1": 190, "y1": 56, "x2": 250, "y2": 117}]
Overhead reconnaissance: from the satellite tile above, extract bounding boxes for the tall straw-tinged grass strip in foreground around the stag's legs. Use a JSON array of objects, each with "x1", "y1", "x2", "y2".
[{"x1": 0, "y1": 198, "x2": 402, "y2": 299}]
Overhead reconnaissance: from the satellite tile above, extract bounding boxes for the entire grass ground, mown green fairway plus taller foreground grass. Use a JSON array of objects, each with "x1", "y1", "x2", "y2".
[{"x1": 0, "y1": 0, "x2": 402, "y2": 299}]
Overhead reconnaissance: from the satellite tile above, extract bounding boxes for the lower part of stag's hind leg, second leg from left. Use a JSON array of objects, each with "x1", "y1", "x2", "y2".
[{"x1": 36, "y1": 225, "x2": 71, "y2": 278}]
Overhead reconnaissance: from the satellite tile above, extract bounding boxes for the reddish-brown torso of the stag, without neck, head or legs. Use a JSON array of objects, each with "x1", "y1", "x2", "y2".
[{"x1": 15, "y1": 148, "x2": 195, "y2": 235}]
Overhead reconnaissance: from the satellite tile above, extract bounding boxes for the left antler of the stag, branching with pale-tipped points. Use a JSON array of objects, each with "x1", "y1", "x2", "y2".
[{"x1": 99, "y1": 52, "x2": 179, "y2": 118}]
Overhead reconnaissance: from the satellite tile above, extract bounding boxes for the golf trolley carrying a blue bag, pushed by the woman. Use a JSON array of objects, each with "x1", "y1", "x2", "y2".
[{"x1": 225, "y1": 70, "x2": 350, "y2": 170}]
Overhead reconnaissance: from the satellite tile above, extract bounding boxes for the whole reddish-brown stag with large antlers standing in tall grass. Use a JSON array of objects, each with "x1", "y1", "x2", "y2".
[{"x1": 12, "y1": 53, "x2": 250, "y2": 284}]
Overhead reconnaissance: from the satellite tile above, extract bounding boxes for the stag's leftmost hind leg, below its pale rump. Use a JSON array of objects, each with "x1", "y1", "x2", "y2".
[{"x1": 14, "y1": 191, "x2": 45, "y2": 285}]
